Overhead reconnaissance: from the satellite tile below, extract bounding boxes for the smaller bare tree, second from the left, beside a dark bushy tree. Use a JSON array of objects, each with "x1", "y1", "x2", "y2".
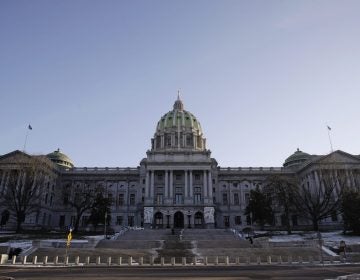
[{"x1": 62, "y1": 182, "x2": 104, "y2": 232}]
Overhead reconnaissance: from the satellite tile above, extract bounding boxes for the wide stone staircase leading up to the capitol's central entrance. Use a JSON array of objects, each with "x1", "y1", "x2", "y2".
[{"x1": 27, "y1": 229, "x2": 326, "y2": 264}]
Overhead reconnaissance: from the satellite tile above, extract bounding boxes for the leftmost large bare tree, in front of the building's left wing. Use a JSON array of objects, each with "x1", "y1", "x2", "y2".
[{"x1": 2, "y1": 155, "x2": 48, "y2": 232}]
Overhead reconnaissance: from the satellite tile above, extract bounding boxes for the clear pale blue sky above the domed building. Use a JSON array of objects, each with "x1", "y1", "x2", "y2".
[{"x1": 0, "y1": 0, "x2": 360, "y2": 167}]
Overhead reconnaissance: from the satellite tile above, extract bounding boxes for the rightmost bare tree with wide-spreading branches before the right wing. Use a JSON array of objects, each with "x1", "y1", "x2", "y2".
[{"x1": 294, "y1": 168, "x2": 348, "y2": 231}]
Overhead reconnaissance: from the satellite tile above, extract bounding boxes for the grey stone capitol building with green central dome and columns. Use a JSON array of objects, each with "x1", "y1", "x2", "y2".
[{"x1": 0, "y1": 97, "x2": 360, "y2": 230}]
